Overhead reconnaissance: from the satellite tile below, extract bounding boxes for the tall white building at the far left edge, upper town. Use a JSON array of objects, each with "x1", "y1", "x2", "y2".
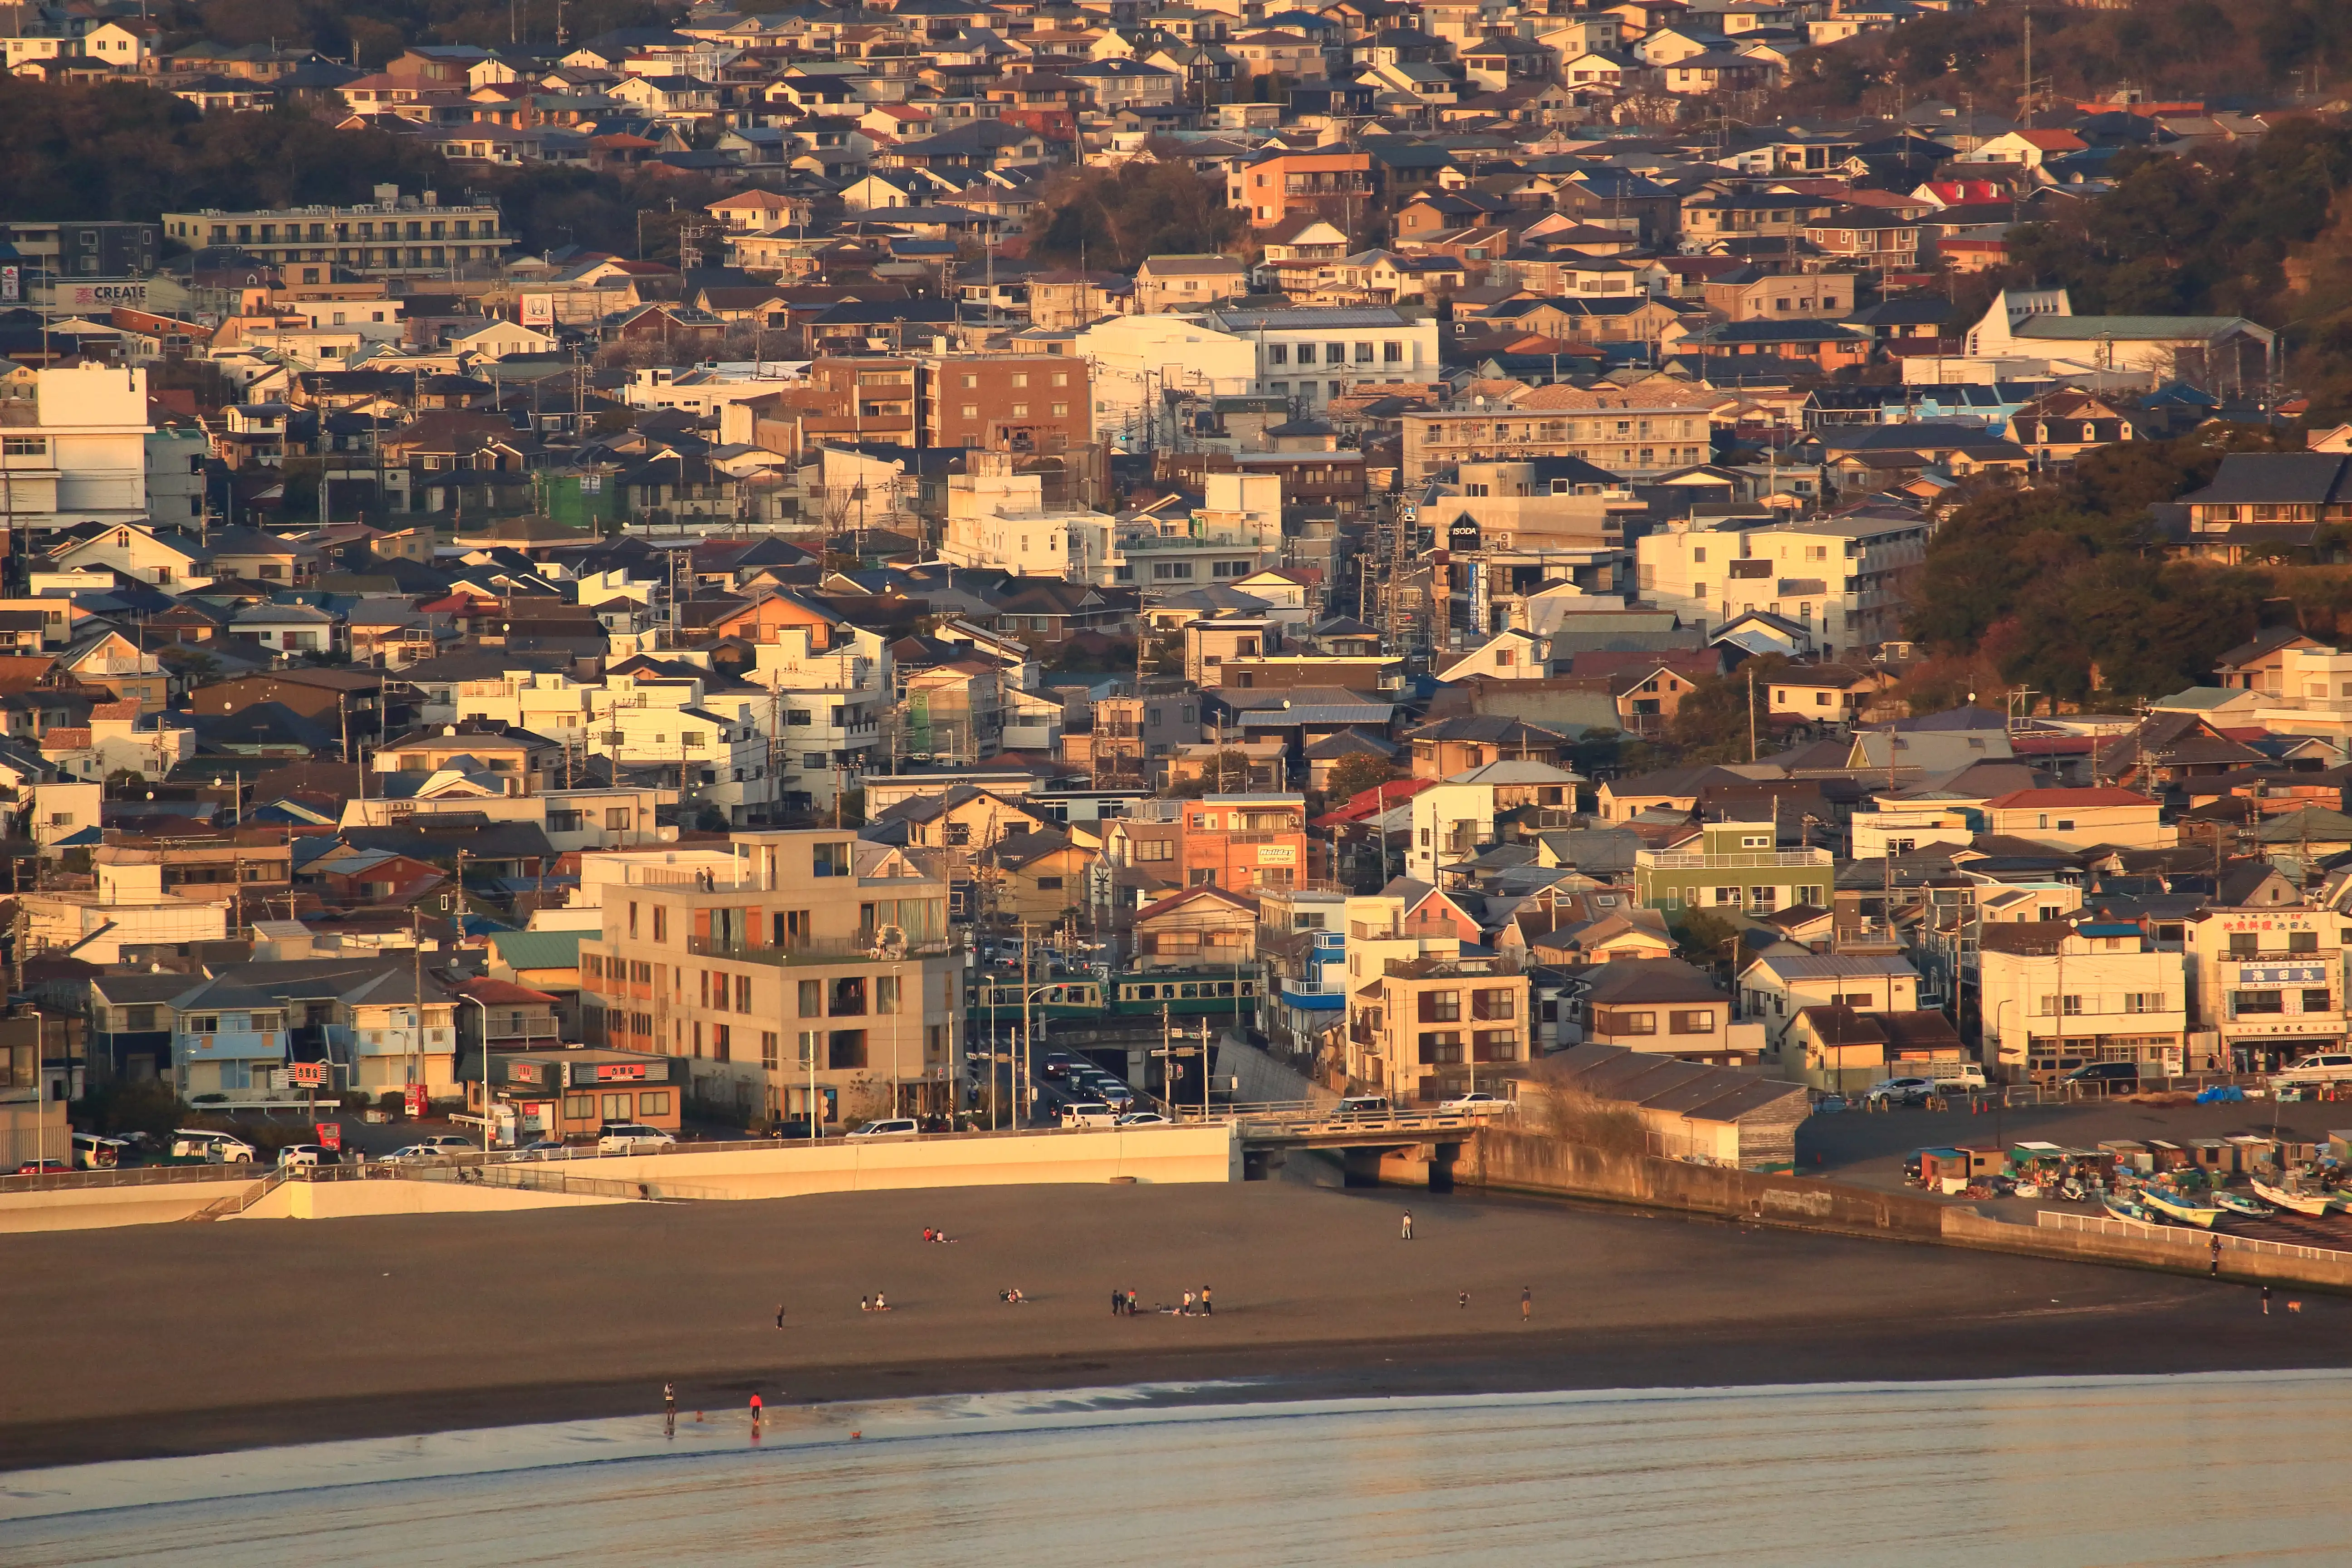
[{"x1": 0, "y1": 364, "x2": 150, "y2": 534}]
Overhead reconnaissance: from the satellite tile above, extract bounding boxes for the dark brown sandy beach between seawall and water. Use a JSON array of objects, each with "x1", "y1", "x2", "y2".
[{"x1": 0, "y1": 1180, "x2": 2352, "y2": 1469}]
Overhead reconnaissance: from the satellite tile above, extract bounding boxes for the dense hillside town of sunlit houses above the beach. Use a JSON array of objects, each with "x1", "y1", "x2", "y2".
[{"x1": 0, "y1": 0, "x2": 2352, "y2": 1175}]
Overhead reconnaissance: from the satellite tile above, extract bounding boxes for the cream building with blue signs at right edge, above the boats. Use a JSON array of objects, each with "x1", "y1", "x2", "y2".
[{"x1": 2180, "y1": 905, "x2": 2352, "y2": 1072}]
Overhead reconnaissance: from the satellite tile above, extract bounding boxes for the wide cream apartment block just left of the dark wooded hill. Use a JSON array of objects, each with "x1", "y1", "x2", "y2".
[{"x1": 1635, "y1": 515, "x2": 1933, "y2": 658}]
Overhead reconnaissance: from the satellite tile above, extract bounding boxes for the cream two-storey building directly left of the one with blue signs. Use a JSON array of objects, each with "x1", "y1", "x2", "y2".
[{"x1": 1976, "y1": 919, "x2": 2187, "y2": 1084}]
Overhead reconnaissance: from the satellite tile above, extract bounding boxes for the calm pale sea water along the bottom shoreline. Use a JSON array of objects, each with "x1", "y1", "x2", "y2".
[{"x1": 0, "y1": 1371, "x2": 2352, "y2": 1568}]
